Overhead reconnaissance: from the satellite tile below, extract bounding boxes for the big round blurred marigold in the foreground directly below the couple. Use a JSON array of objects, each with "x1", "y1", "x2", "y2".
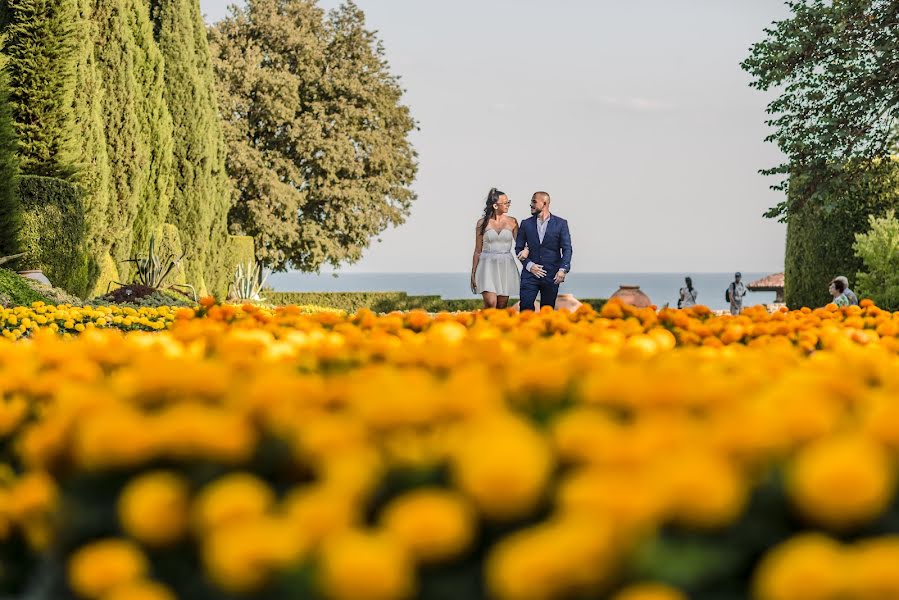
[{"x1": 452, "y1": 417, "x2": 553, "y2": 520}]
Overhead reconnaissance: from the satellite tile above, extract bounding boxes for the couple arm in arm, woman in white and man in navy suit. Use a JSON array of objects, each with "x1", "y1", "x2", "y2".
[{"x1": 471, "y1": 188, "x2": 571, "y2": 310}]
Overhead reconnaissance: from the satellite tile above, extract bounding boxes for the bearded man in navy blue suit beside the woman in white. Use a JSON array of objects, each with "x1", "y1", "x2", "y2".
[{"x1": 515, "y1": 192, "x2": 571, "y2": 311}]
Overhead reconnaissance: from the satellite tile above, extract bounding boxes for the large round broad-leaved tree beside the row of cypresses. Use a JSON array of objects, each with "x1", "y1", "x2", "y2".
[{"x1": 210, "y1": 0, "x2": 417, "y2": 270}]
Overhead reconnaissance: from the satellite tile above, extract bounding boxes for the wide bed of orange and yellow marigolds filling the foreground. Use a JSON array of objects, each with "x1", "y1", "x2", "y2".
[{"x1": 0, "y1": 302, "x2": 899, "y2": 600}]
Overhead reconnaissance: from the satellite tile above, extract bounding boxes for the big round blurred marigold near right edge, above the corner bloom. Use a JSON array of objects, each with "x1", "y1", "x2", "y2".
[{"x1": 787, "y1": 435, "x2": 895, "y2": 529}]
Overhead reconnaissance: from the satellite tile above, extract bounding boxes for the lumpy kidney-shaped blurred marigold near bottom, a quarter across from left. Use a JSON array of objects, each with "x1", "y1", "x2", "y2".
[{"x1": 203, "y1": 517, "x2": 308, "y2": 594}]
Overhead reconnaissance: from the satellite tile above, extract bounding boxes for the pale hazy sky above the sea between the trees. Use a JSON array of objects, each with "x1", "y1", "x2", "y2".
[{"x1": 201, "y1": 0, "x2": 787, "y2": 273}]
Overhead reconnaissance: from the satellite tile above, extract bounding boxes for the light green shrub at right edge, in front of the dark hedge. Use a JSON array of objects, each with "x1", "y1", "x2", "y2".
[{"x1": 853, "y1": 210, "x2": 899, "y2": 310}]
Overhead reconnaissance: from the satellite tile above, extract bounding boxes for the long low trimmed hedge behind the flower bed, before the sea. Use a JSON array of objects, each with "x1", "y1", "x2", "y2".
[{"x1": 262, "y1": 292, "x2": 606, "y2": 313}]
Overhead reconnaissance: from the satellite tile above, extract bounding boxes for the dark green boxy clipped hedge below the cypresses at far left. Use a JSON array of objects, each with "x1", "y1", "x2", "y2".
[{"x1": 19, "y1": 176, "x2": 88, "y2": 297}]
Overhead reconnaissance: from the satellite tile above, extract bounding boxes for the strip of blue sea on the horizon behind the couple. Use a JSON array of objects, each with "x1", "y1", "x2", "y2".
[{"x1": 268, "y1": 271, "x2": 774, "y2": 309}]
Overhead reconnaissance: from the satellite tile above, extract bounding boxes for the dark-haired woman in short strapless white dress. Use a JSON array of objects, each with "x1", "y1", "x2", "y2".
[{"x1": 471, "y1": 188, "x2": 527, "y2": 308}]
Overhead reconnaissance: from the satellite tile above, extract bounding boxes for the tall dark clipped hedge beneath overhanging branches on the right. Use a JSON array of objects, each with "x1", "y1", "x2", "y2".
[{"x1": 784, "y1": 161, "x2": 899, "y2": 309}]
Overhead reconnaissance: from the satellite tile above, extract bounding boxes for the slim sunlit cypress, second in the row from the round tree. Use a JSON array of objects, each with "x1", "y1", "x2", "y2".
[{"x1": 128, "y1": 0, "x2": 175, "y2": 255}]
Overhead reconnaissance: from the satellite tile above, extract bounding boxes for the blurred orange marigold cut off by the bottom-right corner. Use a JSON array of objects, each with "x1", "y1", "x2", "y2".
[{"x1": 846, "y1": 535, "x2": 899, "y2": 600}]
